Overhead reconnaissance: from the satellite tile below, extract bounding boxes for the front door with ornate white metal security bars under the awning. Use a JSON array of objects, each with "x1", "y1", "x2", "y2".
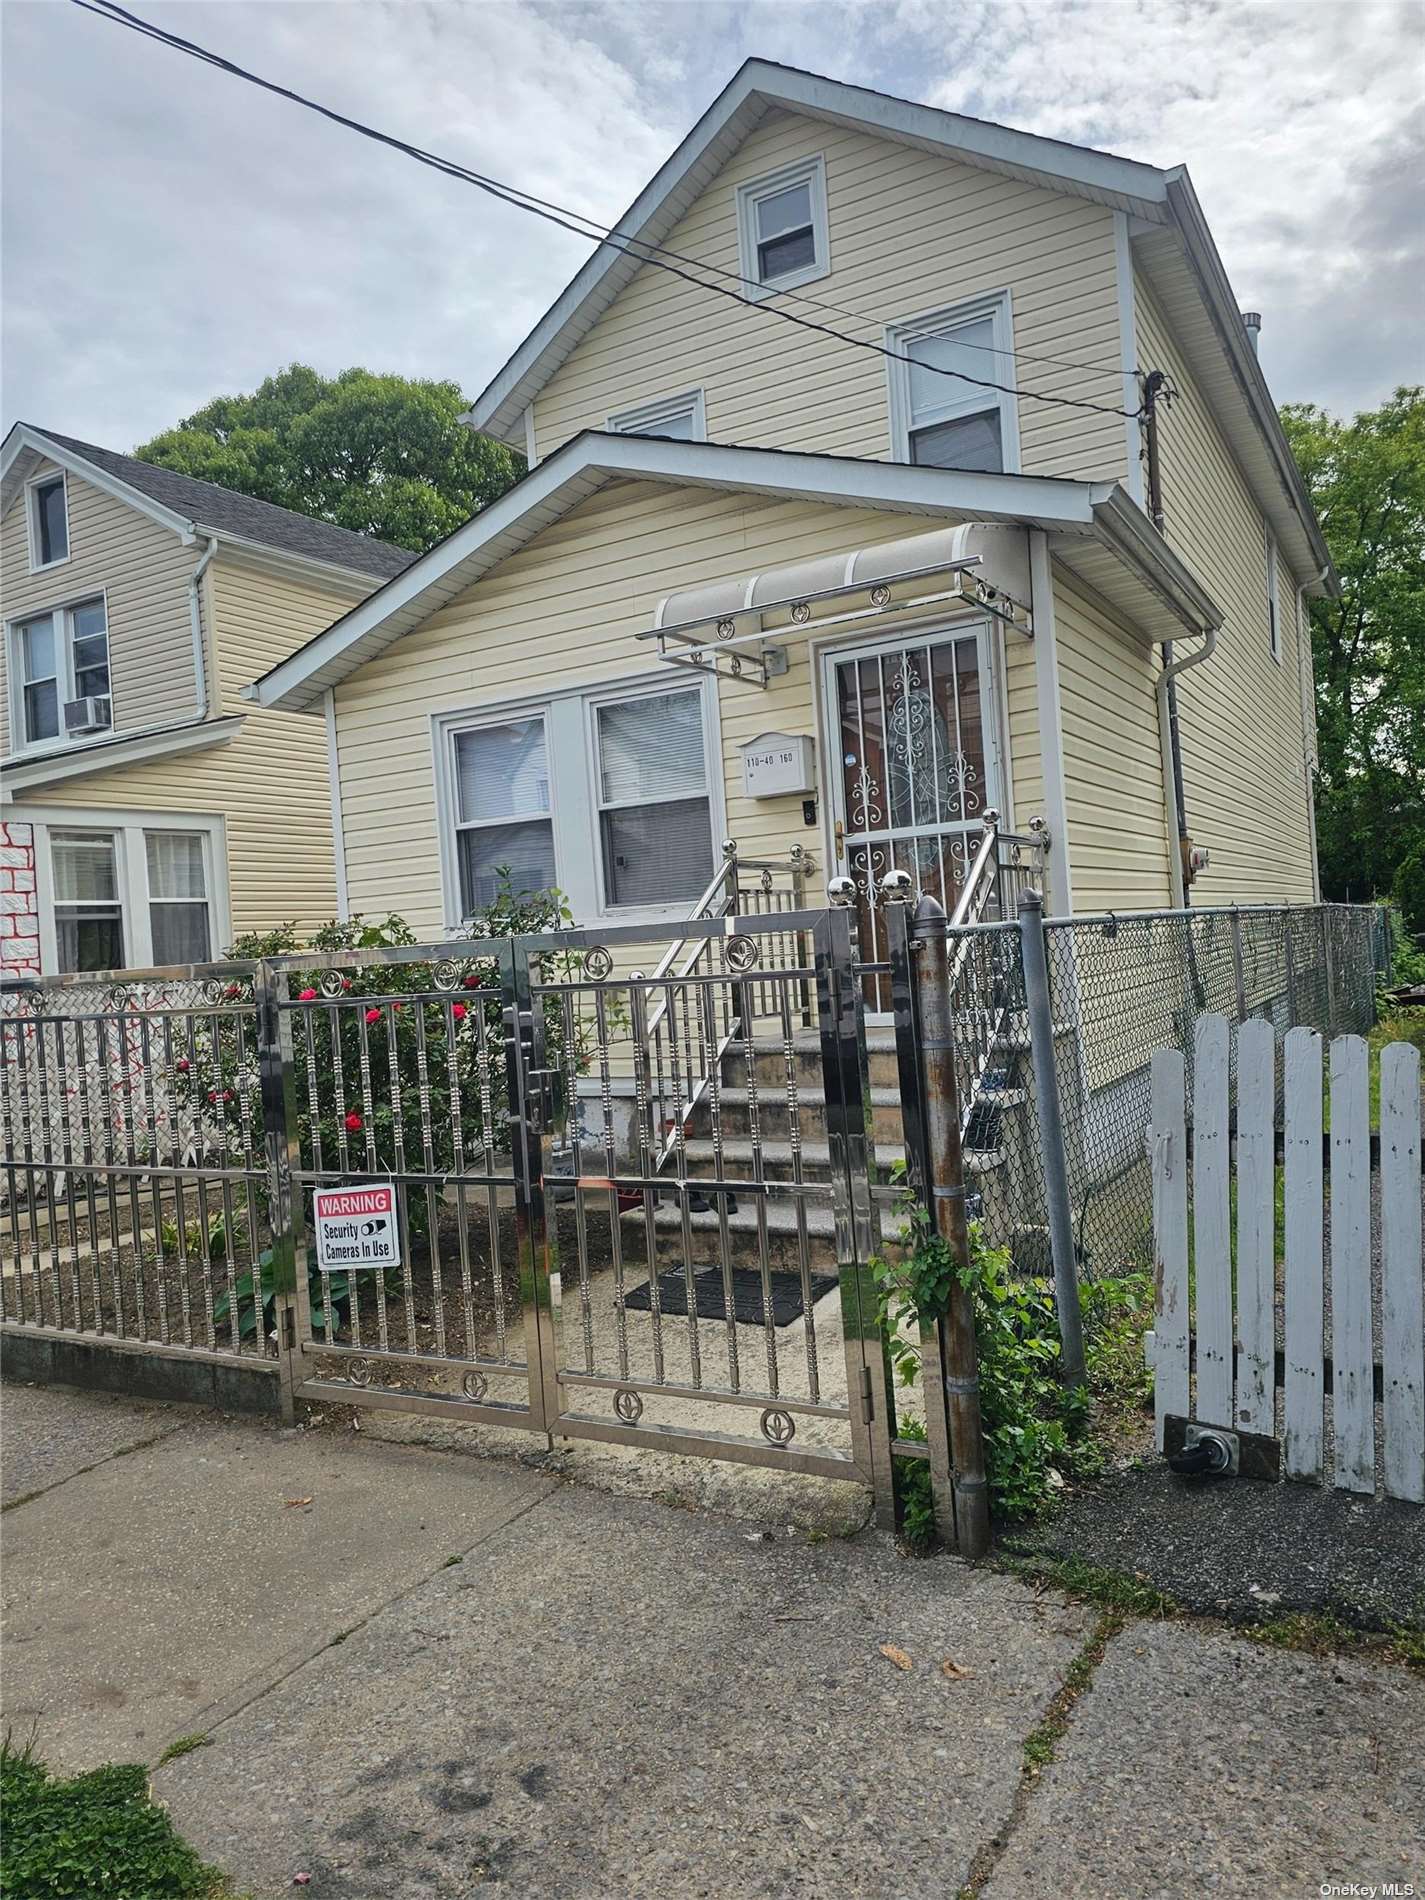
[{"x1": 823, "y1": 629, "x2": 996, "y2": 1015}]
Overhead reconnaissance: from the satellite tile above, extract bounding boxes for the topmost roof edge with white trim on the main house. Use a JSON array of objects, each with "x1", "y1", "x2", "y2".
[{"x1": 469, "y1": 59, "x2": 1332, "y2": 589}]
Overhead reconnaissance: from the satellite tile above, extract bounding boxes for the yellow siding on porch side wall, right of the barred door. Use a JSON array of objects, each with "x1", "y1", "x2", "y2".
[{"x1": 1055, "y1": 568, "x2": 1172, "y2": 912}]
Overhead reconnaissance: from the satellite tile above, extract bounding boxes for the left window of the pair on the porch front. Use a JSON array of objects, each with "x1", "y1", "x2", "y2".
[{"x1": 456, "y1": 716, "x2": 555, "y2": 916}]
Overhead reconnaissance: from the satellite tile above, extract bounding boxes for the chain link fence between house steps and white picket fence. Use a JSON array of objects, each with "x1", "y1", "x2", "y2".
[{"x1": 950, "y1": 904, "x2": 1389, "y2": 1279}]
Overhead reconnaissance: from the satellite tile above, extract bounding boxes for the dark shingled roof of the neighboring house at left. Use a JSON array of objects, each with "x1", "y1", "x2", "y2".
[{"x1": 6, "y1": 422, "x2": 416, "y2": 580}]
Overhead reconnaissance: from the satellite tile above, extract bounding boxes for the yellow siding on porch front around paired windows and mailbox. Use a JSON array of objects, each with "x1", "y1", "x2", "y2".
[{"x1": 336, "y1": 483, "x2": 1041, "y2": 931}]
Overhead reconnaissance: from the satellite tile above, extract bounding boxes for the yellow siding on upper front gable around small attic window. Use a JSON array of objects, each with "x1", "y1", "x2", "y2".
[{"x1": 534, "y1": 112, "x2": 1127, "y2": 479}]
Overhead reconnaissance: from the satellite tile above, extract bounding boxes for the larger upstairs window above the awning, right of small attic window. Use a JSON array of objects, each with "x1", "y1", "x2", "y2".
[{"x1": 885, "y1": 293, "x2": 1018, "y2": 475}]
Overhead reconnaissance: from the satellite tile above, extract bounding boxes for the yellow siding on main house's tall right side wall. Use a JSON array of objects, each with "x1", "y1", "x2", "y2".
[{"x1": 1134, "y1": 272, "x2": 1313, "y2": 904}]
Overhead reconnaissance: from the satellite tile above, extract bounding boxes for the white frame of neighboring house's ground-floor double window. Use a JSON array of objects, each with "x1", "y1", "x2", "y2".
[{"x1": 30, "y1": 806, "x2": 232, "y2": 971}]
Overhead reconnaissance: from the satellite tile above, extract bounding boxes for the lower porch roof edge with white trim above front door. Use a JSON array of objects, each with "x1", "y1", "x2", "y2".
[{"x1": 243, "y1": 429, "x2": 1222, "y2": 713}]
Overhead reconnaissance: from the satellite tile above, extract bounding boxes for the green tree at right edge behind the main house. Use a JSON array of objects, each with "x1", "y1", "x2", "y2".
[{"x1": 1281, "y1": 388, "x2": 1425, "y2": 931}]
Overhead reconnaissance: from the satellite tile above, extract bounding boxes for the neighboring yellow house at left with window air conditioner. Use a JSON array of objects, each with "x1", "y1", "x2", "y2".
[{"x1": 0, "y1": 424, "x2": 412, "y2": 977}]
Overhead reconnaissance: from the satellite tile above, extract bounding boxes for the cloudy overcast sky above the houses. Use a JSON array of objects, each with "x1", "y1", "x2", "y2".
[{"x1": 0, "y1": 0, "x2": 1425, "y2": 448}]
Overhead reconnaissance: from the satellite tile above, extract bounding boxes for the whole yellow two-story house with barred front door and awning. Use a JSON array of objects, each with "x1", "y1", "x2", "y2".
[{"x1": 253, "y1": 61, "x2": 1336, "y2": 980}]
